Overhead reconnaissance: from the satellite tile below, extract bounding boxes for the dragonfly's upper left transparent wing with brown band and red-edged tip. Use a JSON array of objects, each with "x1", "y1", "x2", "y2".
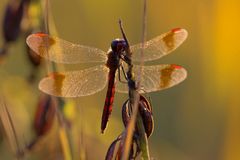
[{"x1": 26, "y1": 33, "x2": 107, "y2": 64}]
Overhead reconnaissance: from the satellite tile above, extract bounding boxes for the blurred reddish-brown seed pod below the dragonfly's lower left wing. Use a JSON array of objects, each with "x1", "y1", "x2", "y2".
[{"x1": 34, "y1": 94, "x2": 57, "y2": 136}]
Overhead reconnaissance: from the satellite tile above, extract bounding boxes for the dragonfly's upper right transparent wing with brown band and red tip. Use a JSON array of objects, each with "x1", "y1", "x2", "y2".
[{"x1": 131, "y1": 28, "x2": 188, "y2": 61}]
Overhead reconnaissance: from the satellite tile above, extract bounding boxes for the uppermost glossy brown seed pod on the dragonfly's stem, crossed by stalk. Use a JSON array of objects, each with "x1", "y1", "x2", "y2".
[{"x1": 122, "y1": 95, "x2": 154, "y2": 137}]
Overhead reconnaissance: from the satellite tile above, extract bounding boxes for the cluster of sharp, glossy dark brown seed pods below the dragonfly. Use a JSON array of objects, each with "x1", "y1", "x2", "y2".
[{"x1": 105, "y1": 95, "x2": 154, "y2": 160}]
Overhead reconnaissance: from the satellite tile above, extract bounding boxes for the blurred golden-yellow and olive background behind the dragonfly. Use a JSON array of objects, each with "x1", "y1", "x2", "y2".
[{"x1": 0, "y1": 0, "x2": 240, "y2": 160}]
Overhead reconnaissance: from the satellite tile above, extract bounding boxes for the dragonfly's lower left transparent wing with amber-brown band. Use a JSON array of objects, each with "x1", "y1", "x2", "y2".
[{"x1": 39, "y1": 65, "x2": 108, "y2": 97}]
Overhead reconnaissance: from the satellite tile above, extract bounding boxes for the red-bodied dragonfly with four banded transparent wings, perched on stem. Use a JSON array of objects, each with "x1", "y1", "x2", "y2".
[{"x1": 26, "y1": 28, "x2": 188, "y2": 133}]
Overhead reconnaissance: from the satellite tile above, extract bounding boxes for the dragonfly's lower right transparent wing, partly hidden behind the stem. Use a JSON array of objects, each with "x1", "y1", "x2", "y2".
[{"x1": 116, "y1": 64, "x2": 187, "y2": 93}]
